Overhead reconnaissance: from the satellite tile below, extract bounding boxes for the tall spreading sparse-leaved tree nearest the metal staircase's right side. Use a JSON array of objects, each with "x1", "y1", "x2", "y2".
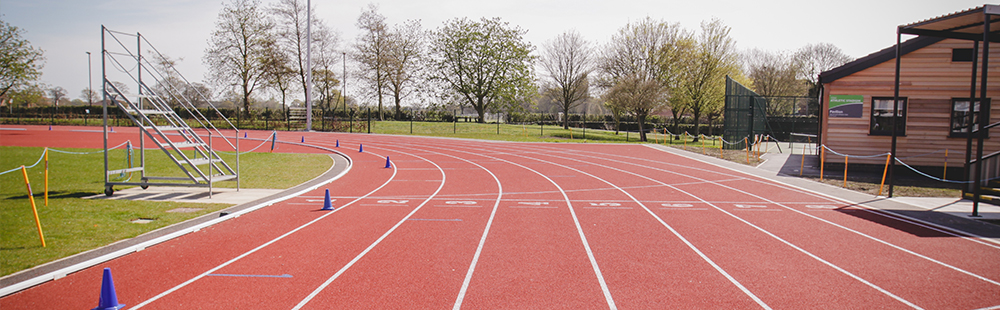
[{"x1": 203, "y1": 0, "x2": 274, "y2": 120}]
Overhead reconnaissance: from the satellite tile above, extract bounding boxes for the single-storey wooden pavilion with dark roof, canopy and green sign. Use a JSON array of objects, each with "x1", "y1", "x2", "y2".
[{"x1": 819, "y1": 6, "x2": 1000, "y2": 172}]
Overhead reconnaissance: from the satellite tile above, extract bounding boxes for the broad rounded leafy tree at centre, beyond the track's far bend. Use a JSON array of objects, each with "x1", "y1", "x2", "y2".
[{"x1": 431, "y1": 18, "x2": 536, "y2": 123}]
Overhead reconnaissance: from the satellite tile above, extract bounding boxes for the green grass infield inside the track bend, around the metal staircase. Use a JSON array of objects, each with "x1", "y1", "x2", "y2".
[{"x1": 0, "y1": 147, "x2": 333, "y2": 276}]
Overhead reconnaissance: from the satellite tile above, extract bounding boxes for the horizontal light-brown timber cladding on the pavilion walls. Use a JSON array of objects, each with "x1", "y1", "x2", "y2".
[{"x1": 822, "y1": 39, "x2": 1000, "y2": 167}]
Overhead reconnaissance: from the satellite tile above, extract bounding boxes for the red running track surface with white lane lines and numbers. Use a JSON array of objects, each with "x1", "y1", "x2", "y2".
[{"x1": 0, "y1": 126, "x2": 1000, "y2": 309}]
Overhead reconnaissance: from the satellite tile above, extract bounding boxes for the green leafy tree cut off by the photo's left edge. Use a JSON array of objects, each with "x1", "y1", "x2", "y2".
[{"x1": 0, "y1": 21, "x2": 45, "y2": 98}]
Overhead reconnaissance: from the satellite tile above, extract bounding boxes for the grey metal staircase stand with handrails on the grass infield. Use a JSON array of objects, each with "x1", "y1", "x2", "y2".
[{"x1": 102, "y1": 27, "x2": 239, "y2": 196}]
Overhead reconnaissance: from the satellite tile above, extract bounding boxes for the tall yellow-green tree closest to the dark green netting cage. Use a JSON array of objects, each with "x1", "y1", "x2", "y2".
[{"x1": 672, "y1": 19, "x2": 740, "y2": 141}]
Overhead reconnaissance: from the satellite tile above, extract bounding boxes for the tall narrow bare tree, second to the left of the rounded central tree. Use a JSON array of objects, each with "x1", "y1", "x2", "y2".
[{"x1": 352, "y1": 4, "x2": 392, "y2": 120}]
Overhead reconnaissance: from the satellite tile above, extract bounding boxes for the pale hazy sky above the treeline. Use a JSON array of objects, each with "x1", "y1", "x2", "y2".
[{"x1": 0, "y1": 0, "x2": 984, "y2": 98}]
